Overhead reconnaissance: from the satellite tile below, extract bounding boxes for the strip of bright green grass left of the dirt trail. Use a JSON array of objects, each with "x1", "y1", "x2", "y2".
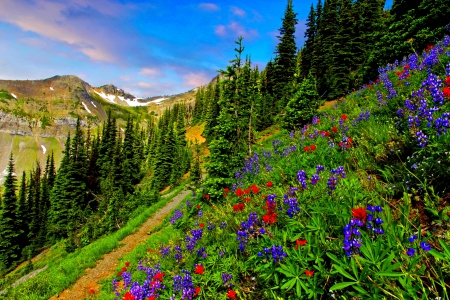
[{"x1": 6, "y1": 187, "x2": 188, "y2": 300}]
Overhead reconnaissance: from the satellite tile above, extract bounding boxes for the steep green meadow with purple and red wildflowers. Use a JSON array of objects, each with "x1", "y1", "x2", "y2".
[{"x1": 101, "y1": 36, "x2": 450, "y2": 300}]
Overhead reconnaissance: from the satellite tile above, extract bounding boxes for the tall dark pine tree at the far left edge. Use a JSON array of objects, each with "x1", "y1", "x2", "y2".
[{"x1": 0, "y1": 154, "x2": 20, "y2": 271}]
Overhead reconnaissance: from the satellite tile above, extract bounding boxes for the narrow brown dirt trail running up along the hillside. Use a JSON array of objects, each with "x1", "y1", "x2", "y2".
[{"x1": 50, "y1": 191, "x2": 191, "y2": 300}]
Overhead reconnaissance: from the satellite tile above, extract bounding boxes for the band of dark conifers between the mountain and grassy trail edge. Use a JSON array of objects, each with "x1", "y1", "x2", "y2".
[{"x1": 0, "y1": 104, "x2": 191, "y2": 274}]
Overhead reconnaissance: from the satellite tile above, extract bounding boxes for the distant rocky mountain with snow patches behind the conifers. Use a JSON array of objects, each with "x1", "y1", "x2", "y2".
[{"x1": 0, "y1": 75, "x2": 195, "y2": 183}]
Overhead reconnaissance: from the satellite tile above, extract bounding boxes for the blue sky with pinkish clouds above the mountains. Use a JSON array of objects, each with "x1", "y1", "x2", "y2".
[{"x1": 0, "y1": 0, "x2": 392, "y2": 98}]
